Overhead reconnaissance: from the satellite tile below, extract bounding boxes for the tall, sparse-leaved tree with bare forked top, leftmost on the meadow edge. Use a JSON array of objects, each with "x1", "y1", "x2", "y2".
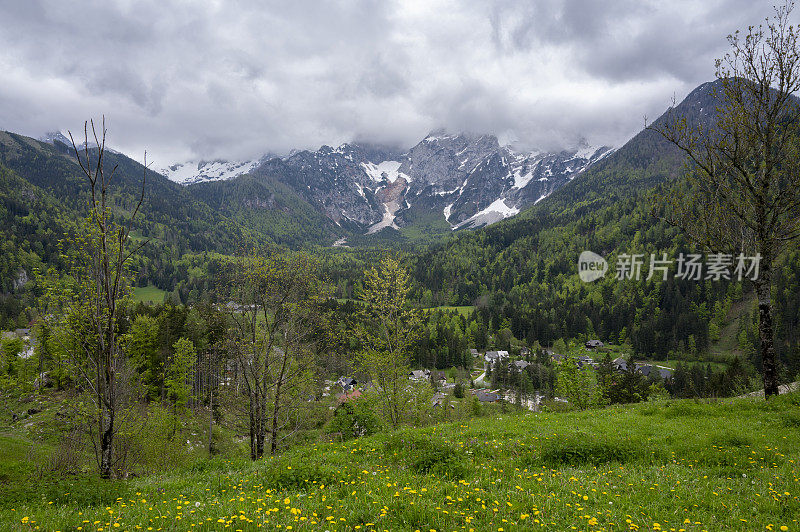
[{"x1": 41, "y1": 118, "x2": 147, "y2": 478}]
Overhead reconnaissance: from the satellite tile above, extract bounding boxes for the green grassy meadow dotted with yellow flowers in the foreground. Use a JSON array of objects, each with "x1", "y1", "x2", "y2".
[{"x1": 0, "y1": 394, "x2": 800, "y2": 532}]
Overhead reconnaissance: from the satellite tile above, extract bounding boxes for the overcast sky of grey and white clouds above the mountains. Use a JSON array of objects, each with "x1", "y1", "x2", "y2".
[{"x1": 0, "y1": 0, "x2": 788, "y2": 168}]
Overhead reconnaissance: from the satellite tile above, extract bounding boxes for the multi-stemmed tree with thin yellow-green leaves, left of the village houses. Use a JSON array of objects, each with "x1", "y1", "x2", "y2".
[{"x1": 225, "y1": 253, "x2": 329, "y2": 460}]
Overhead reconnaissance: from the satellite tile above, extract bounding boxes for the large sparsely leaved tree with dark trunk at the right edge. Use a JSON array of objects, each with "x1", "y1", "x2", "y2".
[{"x1": 651, "y1": 3, "x2": 800, "y2": 397}]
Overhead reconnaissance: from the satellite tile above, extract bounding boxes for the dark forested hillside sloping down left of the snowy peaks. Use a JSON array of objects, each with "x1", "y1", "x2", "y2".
[{"x1": 0, "y1": 132, "x2": 340, "y2": 328}]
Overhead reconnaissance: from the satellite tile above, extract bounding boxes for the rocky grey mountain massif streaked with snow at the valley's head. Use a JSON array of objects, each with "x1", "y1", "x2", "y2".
[{"x1": 238, "y1": 131, "x2": 613, "y2": 233}]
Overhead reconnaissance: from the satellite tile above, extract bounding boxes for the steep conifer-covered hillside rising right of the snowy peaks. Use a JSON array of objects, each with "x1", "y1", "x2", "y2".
[{"x1": 411, "y1": 83, "x2": 800, "y2": 371}]
